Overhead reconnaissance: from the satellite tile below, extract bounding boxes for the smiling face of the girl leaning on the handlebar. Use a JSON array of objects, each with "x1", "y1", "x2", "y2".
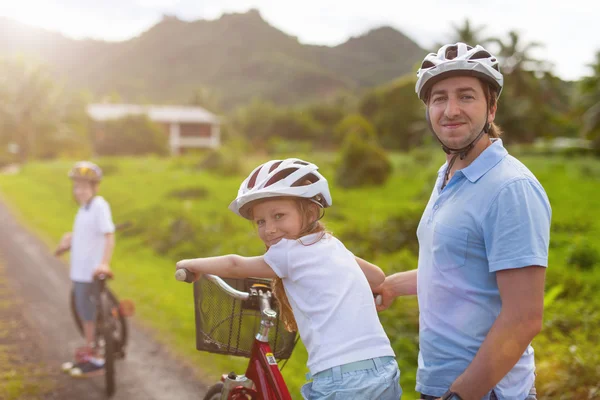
[{"x1": 252, "y1": 199, "x2": 303, "y2": 247}]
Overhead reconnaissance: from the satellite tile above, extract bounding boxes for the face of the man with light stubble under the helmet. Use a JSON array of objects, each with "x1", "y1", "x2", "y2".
[{"x1": 427, "y1": 76, "x2": 496, "y2": 149}]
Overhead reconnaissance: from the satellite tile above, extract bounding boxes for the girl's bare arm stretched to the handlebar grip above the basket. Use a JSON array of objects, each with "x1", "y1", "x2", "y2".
[{"x1": 176, "y1": 254, "x2": 277, "y2": 281}]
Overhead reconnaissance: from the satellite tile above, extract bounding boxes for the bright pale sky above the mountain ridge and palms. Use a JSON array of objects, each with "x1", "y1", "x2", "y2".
[{"x1": 0, "y1": 0, "x2": 600, "y2": 79}]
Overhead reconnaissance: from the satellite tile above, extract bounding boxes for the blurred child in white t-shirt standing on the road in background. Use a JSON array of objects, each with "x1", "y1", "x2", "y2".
[{"x1": 55, "y1": 161, "x2": 115, "y2": 377}]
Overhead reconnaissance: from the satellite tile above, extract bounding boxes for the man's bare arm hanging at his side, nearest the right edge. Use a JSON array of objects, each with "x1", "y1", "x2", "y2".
[{"x1": 450, "y1": 266, "x2": 546, "y2": 400}]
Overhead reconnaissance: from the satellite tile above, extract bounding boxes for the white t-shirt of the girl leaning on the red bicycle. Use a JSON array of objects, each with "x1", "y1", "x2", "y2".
[{"x1": 264, "y1": 233, "x2": 394, "y2": 375}]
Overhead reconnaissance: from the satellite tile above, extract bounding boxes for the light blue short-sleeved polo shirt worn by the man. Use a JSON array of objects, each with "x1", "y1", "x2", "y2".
[{"x1": 416, "y1": 139, "x2": 551, "y2": 400}]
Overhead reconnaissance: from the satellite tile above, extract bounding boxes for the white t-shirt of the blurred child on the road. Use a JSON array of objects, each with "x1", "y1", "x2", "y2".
[{"x1": 71, "y1": 196, "x2": 115, "y2": 282}]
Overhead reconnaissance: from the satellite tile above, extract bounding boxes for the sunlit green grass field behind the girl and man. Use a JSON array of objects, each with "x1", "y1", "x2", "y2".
[{"x1": 0, "y1": 149, "x2": 600, "y2": 399}]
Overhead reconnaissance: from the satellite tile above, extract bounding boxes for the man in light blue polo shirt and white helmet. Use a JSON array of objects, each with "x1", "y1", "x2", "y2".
[{"x1": 376, "y1": 43, "x2": 551, "y2": 400}]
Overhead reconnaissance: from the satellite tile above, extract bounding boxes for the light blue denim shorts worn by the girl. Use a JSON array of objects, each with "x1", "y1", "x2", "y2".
[{"x1": 301, "y1": 357, "x2": 402, "y2": 400}]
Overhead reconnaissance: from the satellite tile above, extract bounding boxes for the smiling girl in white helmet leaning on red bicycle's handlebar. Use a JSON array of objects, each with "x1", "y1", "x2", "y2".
[{"x1": 177, "y1": 158, "x2": 402, "y2": 400}]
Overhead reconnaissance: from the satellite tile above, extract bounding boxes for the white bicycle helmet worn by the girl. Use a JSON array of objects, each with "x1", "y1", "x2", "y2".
[{"x1": 229, "y1": 158, "x2": 332, "y2": 219}]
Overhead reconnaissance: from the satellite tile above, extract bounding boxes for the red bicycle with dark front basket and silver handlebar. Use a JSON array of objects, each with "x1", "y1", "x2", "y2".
[{"x1": 175, "y1": 269, "x2": 297, "y2": 400}]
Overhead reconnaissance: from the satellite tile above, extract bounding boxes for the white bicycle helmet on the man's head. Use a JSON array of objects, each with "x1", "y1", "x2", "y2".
[{"x1": 415, "y1": 42, "x2": 504, "y2": 101}]
